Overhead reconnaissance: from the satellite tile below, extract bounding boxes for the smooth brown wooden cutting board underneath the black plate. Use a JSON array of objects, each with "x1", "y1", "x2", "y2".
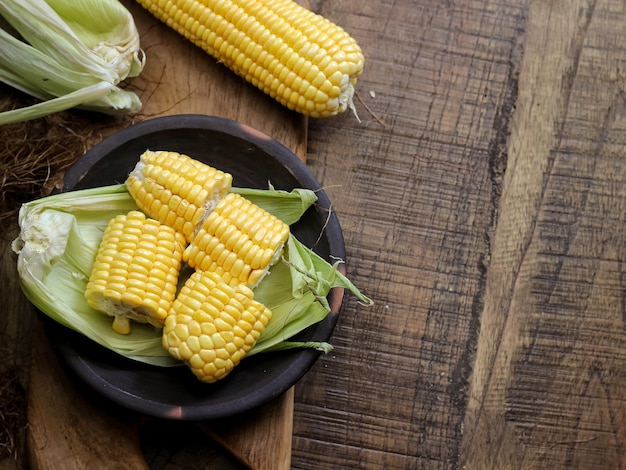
[{"x1": 28, "y1": 1, "x2": 307, "y2": 470}]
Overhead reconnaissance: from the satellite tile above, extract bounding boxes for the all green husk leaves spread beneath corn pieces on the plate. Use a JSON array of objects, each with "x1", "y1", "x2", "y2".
[{"x1": 13, "y1": 185, "x2": 371, "y2": 366}]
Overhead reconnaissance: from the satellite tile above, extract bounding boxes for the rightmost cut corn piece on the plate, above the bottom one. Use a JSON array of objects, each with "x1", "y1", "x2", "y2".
[{"x1": 183, "y1": 193, "x2": 289, "y2": 287}]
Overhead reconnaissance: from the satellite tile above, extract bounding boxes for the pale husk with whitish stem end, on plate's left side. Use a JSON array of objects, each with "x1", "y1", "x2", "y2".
[{"x1": 13, "y1": 186, "x2": 173, "y2": 363}]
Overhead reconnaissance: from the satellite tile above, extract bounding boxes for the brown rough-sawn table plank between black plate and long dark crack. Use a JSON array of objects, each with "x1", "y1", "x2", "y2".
[{"x1": 293, "y1": 1, "x2": 526, "y2": 469}]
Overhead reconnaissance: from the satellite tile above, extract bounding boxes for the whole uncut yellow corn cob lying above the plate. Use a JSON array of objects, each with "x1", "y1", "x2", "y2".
[{"x1": 138, "y1": 0, "x2": 364, "y2": 117}]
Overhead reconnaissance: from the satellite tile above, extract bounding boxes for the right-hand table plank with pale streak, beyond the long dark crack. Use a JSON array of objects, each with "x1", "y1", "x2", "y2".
[{"x1": 461, "y1": 1, "x2": 626, "y2": 469}]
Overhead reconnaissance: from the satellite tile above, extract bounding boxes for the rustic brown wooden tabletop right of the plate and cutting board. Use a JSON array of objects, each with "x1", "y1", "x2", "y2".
[{"x1": 3, "y1": 0, "x2": 626, "y2": 470}]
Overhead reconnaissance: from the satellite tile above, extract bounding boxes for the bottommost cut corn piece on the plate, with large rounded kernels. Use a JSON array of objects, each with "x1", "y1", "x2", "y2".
[{"x1": 163, "y1": 271, "x2": 272, "y2": 382}]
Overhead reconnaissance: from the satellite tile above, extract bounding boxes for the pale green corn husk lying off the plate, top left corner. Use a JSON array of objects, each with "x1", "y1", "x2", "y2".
[{"x1": 0, "y1": 0, "x2": 144, "y2": 124}]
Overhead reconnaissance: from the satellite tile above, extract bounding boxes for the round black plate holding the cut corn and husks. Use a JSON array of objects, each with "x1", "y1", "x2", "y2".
[{"x1": 48, "y1": 115, "x2": 345, "y2": 420}]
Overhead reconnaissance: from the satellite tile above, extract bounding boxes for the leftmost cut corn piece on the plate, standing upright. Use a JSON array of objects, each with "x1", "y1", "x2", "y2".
[{"x1": 85, "y1": 211, "x2": 185, "y2": 334}]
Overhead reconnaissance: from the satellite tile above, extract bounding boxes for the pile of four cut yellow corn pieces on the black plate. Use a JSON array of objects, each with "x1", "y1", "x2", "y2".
[{"x1": 85, "y1": 150, "x2": 289, "y2": 382}]
